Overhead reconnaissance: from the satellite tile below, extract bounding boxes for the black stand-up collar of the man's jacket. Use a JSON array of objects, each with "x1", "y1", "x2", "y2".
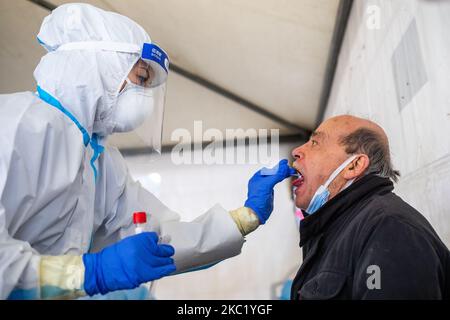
[{"x1": 300, "y1": 174, "x2": 394, "y2": 247}]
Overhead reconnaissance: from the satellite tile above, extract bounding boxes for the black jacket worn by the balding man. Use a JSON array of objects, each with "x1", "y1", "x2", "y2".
[{"x1": 291, "y1": 175, "x2": 450, "y2": 300}]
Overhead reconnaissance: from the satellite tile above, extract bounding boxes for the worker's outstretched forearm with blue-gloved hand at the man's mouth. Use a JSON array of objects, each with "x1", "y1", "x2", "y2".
[{"x1": 161, "y1": 160, "x2": 294, "y2": 272}]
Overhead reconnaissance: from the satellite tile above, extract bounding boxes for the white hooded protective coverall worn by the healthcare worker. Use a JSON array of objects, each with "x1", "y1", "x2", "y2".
[{"x1": 0, "y1": 4, "x2": 260, "y2": 299}]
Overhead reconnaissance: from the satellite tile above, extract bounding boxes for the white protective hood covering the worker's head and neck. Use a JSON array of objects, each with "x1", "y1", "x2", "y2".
[{"x1": 34, "y1": 3, "x2": 151, "y2": 136}]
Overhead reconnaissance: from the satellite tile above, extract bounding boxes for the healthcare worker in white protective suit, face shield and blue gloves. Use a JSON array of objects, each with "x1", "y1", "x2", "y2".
[{"x1": 0, "y1": 4, "x2": 294, "y2": 299}]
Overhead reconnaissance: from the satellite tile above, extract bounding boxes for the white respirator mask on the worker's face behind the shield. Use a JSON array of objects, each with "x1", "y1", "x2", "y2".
[{"x1": 113, "y1": 78, "x2": 155, "y2": 132}]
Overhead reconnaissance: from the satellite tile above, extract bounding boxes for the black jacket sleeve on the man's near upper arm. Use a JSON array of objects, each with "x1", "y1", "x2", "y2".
[{"x1": 352, "y1": 216, "x2": 443, "y2": 300}]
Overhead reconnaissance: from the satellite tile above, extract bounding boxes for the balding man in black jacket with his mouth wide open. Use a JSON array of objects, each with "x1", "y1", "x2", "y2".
[{"x1": 284, "y1": 115, "x2": 450, "y2": 299}]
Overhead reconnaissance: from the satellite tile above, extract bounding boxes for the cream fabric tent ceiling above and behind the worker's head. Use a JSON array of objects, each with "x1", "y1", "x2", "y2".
[{"x1": 0, "y1": 0, "x2": 339, "y2": 148}]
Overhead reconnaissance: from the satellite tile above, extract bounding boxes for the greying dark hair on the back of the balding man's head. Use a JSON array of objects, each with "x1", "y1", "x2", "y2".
[{"x1": 340, "y1": 128, "x2": 400, "y2": 182}]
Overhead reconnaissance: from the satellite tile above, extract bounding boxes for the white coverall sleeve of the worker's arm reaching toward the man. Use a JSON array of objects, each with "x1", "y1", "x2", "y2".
[{"x1": 92, "y1": 165, "x2": 244, "y2": 273}]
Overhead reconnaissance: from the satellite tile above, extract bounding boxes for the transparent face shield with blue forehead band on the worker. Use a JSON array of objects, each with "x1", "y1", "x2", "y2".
[{"x1": 112, "y1": 43, "x2": 169, "y2": 156}]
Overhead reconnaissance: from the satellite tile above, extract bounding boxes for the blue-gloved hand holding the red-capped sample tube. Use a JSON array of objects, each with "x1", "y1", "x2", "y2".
[{"x1": 83, "y1": 232, "x2": 176, "y2": 295}]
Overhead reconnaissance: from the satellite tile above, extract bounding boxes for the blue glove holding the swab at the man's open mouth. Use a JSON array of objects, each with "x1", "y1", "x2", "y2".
[{"x1": 244, "y1": 159, "x2": 297, "y2": 224}]
